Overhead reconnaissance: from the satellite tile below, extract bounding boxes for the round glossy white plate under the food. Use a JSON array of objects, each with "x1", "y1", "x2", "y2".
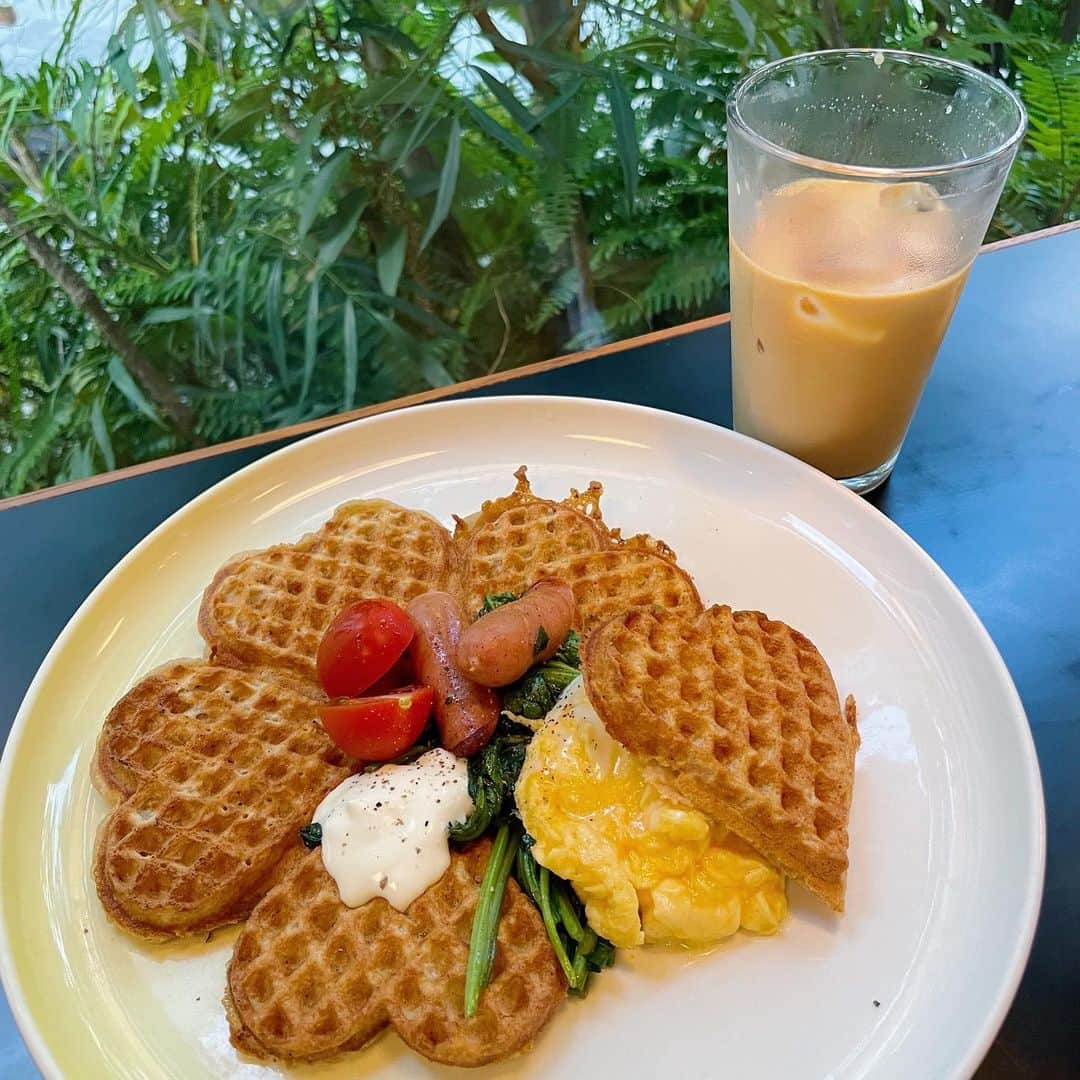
[{"x1": 0, "y1": 397, "x2": 1044, "y2": 1078}]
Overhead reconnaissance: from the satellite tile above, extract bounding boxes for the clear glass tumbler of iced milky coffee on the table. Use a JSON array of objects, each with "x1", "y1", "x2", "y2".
[{"x1": 728, "y1": 49, "x2": 1027, "y2": 492}]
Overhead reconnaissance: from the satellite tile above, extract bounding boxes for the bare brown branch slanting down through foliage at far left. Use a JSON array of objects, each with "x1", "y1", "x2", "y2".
[{"x1": 0, "y1": 195, "x2": 194, "y2": 436}]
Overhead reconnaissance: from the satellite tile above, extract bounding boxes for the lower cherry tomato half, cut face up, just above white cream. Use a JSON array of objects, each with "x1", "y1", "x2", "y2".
[{"x1": 319, "y1": 686, "x2": 435, "y2": 761}]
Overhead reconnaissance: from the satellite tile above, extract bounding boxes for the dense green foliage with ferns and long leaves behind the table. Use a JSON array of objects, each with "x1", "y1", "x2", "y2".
[{"x1": 0, "y1": 0, "x2": 1080, "y2": 495}]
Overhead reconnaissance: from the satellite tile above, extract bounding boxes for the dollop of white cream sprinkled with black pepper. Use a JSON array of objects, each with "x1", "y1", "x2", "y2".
[{"x1": 313, "y1": 750, "x2": 473, "y2": 912}]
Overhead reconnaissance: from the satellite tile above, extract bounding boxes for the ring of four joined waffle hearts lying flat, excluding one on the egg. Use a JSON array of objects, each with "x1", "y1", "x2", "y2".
[{"x1": 94, "y1": 469, "x2": 730, "y2": 1065}]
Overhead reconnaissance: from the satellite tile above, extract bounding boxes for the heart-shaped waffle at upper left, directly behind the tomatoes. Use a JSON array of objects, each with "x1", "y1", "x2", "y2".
[{"x1": 199, "y1": 499, "x2": 453, "y2": 683}]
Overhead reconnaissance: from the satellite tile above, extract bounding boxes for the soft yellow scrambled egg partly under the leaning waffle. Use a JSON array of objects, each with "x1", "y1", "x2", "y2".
[{"x1": 516, "y1": 678, "x2": 787, "y2": 947}]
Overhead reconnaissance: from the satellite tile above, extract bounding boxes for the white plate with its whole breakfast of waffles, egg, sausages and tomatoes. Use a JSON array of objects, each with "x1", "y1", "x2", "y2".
[{"x1": 0, "y1": 397, "x2": 1044, "y2": 1078}]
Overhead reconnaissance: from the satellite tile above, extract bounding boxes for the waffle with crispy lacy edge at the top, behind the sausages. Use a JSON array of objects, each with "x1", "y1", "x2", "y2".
[{"x1": 454, "y1": 465, "x2": 701, "y2": 633}]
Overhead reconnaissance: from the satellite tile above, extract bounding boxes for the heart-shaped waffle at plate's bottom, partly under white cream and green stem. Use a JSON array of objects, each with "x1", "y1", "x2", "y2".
[{"x1": 226, "y1": 840, "x2": 566, "y2": 1065}]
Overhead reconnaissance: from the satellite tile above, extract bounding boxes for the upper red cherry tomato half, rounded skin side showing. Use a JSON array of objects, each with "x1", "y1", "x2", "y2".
[{"x1": 315, "y1": 600, "x2": 416, "y2": 698}]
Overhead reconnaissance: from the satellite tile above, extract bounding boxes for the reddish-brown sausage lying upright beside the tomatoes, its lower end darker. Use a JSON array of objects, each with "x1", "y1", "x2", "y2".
[{"x1": 405, "y1": 593, "x2": 499, "y2": 757}]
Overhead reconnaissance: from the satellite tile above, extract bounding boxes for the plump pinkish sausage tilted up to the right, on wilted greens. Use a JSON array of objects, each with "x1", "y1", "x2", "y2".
[{"x1": 457, "y1": 578, "x2": 575, "y2": 686}]
